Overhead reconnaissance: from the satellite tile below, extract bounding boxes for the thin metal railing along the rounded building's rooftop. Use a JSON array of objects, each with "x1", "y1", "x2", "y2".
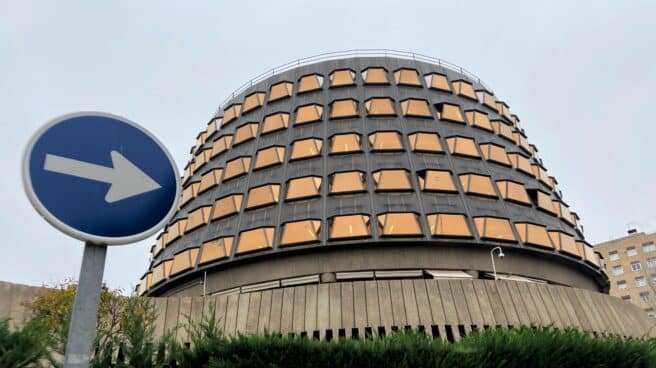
[{"x1": 215, "y1": 49, "x2": 492, "y2": 115}]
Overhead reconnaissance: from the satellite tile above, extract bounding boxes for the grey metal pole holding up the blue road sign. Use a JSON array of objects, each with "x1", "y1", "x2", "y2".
[{"x1": 64, "y1": 242, "x2": 107, "y2": 368}]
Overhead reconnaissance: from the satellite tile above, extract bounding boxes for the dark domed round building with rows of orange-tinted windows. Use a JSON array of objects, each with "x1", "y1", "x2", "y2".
[{"x1": 138, "y1": 53, "x2": 652, "y2": 340}]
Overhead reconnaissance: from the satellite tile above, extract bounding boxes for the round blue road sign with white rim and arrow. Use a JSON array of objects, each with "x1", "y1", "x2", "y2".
[{"x1": 23, "y1": 112, "x2": 180, "y2": 244}]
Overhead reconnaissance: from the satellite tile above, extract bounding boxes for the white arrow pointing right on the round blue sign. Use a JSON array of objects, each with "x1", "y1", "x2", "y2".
[{"x1": 43, "y1": 151, "x2": 162, "y2": 203}]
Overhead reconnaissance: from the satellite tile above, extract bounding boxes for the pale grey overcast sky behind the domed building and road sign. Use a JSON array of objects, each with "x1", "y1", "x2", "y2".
[{"x1": 0, "y1": 0, "x2": 656, "y2": 289}]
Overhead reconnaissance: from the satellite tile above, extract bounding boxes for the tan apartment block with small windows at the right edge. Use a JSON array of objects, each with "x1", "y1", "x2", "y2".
[{"x1": 595, "y1": 230, "x2": 656, "y2": 318}]
